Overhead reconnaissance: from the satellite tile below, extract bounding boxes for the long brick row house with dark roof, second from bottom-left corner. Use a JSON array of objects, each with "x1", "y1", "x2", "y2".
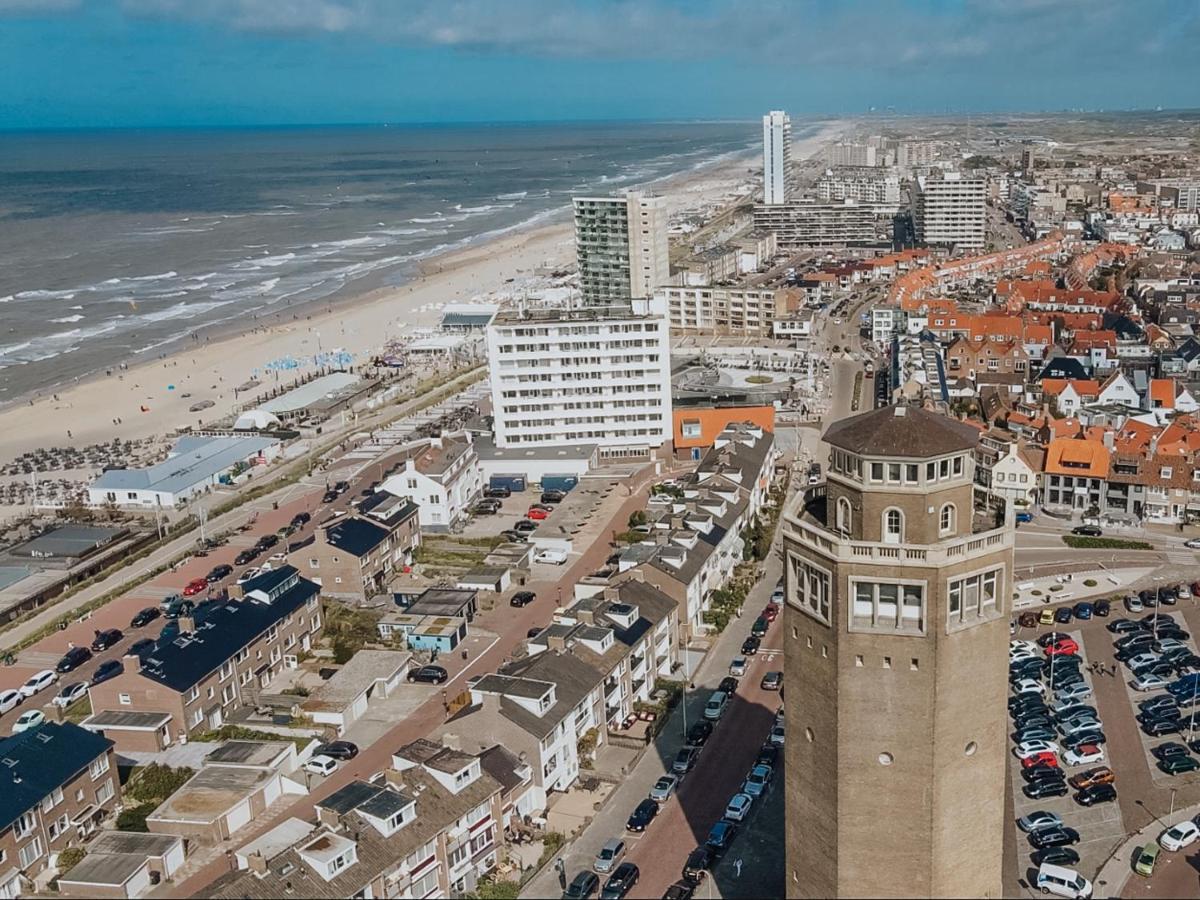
[{"x1": 83, "y1": 565, "x2": 324, "y2": 751}]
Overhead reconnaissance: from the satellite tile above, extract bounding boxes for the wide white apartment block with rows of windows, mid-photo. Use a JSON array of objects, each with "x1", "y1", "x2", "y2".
[{"x1": 487, "y1": 300, "x2": 671, "y2": 457}]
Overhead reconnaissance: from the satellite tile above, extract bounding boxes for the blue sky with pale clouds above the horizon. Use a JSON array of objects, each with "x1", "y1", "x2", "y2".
[{"x1": 0, "y1": 0, "x2": 1200, "y2": 128}]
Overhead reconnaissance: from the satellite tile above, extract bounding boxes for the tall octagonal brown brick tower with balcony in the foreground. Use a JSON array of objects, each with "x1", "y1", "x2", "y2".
[{"x1": 784, "y1": 406, "x2": 1014, "y2": 898}]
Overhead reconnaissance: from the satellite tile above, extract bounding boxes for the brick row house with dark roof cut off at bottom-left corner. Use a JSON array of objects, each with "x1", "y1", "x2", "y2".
[{"x1": 0, "y1": 721, "x2": 121, "y2": 898}]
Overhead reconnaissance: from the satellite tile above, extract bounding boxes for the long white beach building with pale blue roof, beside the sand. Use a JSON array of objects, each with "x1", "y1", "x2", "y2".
[{"x1": 88, "y1": 434, "x2": 281, "y2": 509}]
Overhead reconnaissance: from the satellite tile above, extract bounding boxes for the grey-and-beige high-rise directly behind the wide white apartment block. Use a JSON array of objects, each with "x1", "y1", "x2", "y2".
[{"x1": 575, "y1": 191, "x2": 671, "y2": 306}]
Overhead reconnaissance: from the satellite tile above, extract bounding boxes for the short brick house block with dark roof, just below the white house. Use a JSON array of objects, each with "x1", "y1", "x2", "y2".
[{"x1": 298, "y1": 491, "x2": 421, "y2": 601}]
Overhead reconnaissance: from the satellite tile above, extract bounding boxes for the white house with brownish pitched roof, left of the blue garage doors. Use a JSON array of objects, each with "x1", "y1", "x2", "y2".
[{"x1": 379, "y1": 432, "x2": 484, "y2": 532}]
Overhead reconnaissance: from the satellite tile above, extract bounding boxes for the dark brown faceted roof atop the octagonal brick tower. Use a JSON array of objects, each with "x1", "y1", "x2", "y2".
[{"x1": 824, "y1": 406, "x2": 979, "y2": 460}]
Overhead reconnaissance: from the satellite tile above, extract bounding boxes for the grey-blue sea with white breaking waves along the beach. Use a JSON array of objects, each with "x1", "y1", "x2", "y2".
[{"x1": 0, "y1": 122, "x2": 758, "y2": 403}]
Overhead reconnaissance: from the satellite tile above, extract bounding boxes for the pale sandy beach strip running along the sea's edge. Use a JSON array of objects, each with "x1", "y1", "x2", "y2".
[{"x1": 0, "y1": 122, "x2": 846, "y2": 460}]
